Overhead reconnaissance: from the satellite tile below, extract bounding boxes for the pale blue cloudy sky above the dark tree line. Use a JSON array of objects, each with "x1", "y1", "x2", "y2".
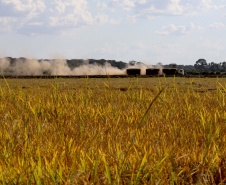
[{"x1": 0, "y1": 0, "x2": 226, "y2": 65}]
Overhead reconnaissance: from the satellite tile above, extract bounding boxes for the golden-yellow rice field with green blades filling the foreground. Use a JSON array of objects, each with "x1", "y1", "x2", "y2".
[{"x1": 0, "y1": 77, "x2": 226, "y2": 185}]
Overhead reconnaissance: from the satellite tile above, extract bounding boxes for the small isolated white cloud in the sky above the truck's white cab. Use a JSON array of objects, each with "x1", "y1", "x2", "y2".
[{"x1": 155, "y1": 23, "x2": 195, "y2": 35}]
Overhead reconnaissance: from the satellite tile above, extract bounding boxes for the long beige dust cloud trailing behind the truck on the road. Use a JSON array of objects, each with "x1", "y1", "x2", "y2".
[{"x1": 0, "y1": 58, "x2": 126, "y2": 75}]
